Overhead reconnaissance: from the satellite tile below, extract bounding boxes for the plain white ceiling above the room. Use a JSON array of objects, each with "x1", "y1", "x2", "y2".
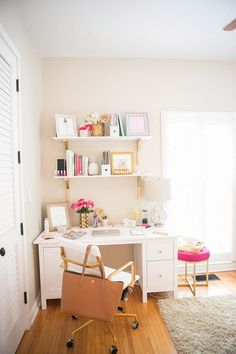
[{"x1": 12, "y1": 0, "x2": 236, "y2": 60}]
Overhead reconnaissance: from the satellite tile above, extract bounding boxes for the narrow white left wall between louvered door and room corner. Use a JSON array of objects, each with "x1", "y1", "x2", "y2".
[{"x1": 0, "y1": 1, "x2": 42, "y2": 309}]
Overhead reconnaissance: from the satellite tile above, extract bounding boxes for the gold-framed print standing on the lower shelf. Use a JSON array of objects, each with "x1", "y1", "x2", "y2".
[{"x1": 111, "y1": 152, "x2": 134, "y2": 175}]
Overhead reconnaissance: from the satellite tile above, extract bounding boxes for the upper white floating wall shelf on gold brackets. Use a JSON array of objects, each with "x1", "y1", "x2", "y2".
[{"x1": 53, "y1": 135, "x2": 152, "y2": 143}]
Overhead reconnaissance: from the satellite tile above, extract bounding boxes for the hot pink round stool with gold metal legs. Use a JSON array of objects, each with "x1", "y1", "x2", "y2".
[{"x1": 178, "y1": 247, "x2": 210, "y2": 296}]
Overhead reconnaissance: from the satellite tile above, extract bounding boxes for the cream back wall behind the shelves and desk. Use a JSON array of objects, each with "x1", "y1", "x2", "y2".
[{"x1": 42, "y1": 58, "x2": 236, "y2": 265}]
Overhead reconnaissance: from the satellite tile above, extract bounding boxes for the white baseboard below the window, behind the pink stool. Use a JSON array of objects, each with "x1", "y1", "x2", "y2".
[{"x1": 178, "y1": 262, "x2": 236, "y2": 274}]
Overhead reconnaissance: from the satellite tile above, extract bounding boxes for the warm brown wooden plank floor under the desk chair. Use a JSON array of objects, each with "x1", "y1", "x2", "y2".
[{"x1": 17, "y1": 272, "x2": 236, "y2": 354}]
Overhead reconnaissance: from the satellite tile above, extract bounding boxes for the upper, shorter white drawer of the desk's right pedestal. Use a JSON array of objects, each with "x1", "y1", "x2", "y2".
[{"x1": 147, "y1": 240, "x2": 174, "y2": 261}]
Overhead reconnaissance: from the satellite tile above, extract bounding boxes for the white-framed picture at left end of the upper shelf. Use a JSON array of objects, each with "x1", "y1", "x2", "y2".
[{"x1": 55, "y1": 114, "x2": 77, "y2": 138}]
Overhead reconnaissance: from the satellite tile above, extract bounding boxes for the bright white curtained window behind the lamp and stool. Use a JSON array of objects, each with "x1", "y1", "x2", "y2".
[{"x1": 161, "y1": 112, "x2": 236, "y2": 261}]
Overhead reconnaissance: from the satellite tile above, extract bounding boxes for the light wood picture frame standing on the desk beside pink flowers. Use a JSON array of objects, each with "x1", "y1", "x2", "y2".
[{"x1": 47, "y1": 203, "x2": 70, "y2": 231}]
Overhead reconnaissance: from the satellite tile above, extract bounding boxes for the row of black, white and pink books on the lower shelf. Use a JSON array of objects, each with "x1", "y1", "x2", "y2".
[{"x1": 56, "y1": 150, "x2": 88, "y2": 177}]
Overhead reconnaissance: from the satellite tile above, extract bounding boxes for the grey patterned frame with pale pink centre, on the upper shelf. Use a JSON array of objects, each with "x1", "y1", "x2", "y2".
[{"x1": 125, "y1": 113, "x2": 149, "y2": 136}]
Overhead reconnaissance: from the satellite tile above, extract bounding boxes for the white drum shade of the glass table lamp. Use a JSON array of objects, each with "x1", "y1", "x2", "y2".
[{"x1": 144, "y1": 178, "x2": 171, "y2": 201}]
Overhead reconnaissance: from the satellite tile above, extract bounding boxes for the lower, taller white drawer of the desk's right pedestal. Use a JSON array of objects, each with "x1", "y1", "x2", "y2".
[{"x1": 147, "y1": 261, "x2": 174, "y2": 292}]
